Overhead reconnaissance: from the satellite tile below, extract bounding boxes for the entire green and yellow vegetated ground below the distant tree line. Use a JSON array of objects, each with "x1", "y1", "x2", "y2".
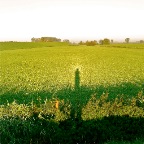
[{"x1": 0, "y1": 43, "x2": 144, "y2": 144}]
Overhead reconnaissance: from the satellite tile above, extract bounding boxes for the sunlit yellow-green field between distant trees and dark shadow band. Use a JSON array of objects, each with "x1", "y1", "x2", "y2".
[{"x1": 0, "y1": 43, "x2": 144, "y2": 104}]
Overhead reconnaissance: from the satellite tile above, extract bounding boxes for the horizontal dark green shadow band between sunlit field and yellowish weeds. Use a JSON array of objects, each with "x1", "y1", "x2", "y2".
[{"x1": 0, "y1": 82, "x2": 144, "y2": 105}]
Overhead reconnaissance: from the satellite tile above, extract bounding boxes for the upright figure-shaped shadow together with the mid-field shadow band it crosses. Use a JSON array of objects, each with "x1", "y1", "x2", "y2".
[{"x1": 0, "y1": 69, "x2": 144, "y2": 124}]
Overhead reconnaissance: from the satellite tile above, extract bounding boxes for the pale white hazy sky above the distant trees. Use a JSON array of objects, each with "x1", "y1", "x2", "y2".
[{"x1": 0, "y1": 0, "x2": 144, "y2": 41}]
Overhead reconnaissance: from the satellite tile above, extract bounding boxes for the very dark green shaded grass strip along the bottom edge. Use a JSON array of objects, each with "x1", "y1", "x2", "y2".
[{"x1": 0, "y1": 116, "x2": 144, "y2": 144}]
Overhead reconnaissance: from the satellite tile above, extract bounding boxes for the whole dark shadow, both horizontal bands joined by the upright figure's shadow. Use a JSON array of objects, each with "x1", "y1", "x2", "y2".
[{"x1": 0, "y1": 69, "x2": 144, "y2": 144}]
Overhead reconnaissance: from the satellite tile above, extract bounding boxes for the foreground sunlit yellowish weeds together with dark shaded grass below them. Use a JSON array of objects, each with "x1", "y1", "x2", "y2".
[{"x1": 0, "y1": 93, "x2": 144, "y2": 144}]
